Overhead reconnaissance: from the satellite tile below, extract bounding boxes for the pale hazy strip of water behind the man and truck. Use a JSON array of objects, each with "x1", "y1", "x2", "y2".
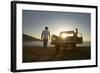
[{"x1": 23, "y1": 41, "x2": 91, "y2": 47}]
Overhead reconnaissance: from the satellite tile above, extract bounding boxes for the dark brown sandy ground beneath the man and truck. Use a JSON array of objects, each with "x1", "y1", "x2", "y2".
[{"x1": 22, "y1": 46, "x2": 91, "y2": 63}]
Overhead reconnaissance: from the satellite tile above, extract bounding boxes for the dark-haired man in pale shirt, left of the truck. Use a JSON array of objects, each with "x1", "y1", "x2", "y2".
[{"x1": 41, "y1": 27, "x2": 50, "y2": 48}]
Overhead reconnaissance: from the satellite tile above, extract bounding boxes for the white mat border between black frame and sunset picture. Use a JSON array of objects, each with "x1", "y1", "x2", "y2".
[{"x1": 16, "y1": 4, "x2": 96, "y2": 70}]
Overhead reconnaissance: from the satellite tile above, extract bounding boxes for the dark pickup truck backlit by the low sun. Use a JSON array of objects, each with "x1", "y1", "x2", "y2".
[{"x1": 51, "y1": 29, "x2": 83, "y2": 50}]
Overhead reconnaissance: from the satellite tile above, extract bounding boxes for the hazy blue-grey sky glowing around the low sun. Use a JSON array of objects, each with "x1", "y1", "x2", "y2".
[{"x1": 22, "y1": 10, "x2": 91, "y2": 41}]
